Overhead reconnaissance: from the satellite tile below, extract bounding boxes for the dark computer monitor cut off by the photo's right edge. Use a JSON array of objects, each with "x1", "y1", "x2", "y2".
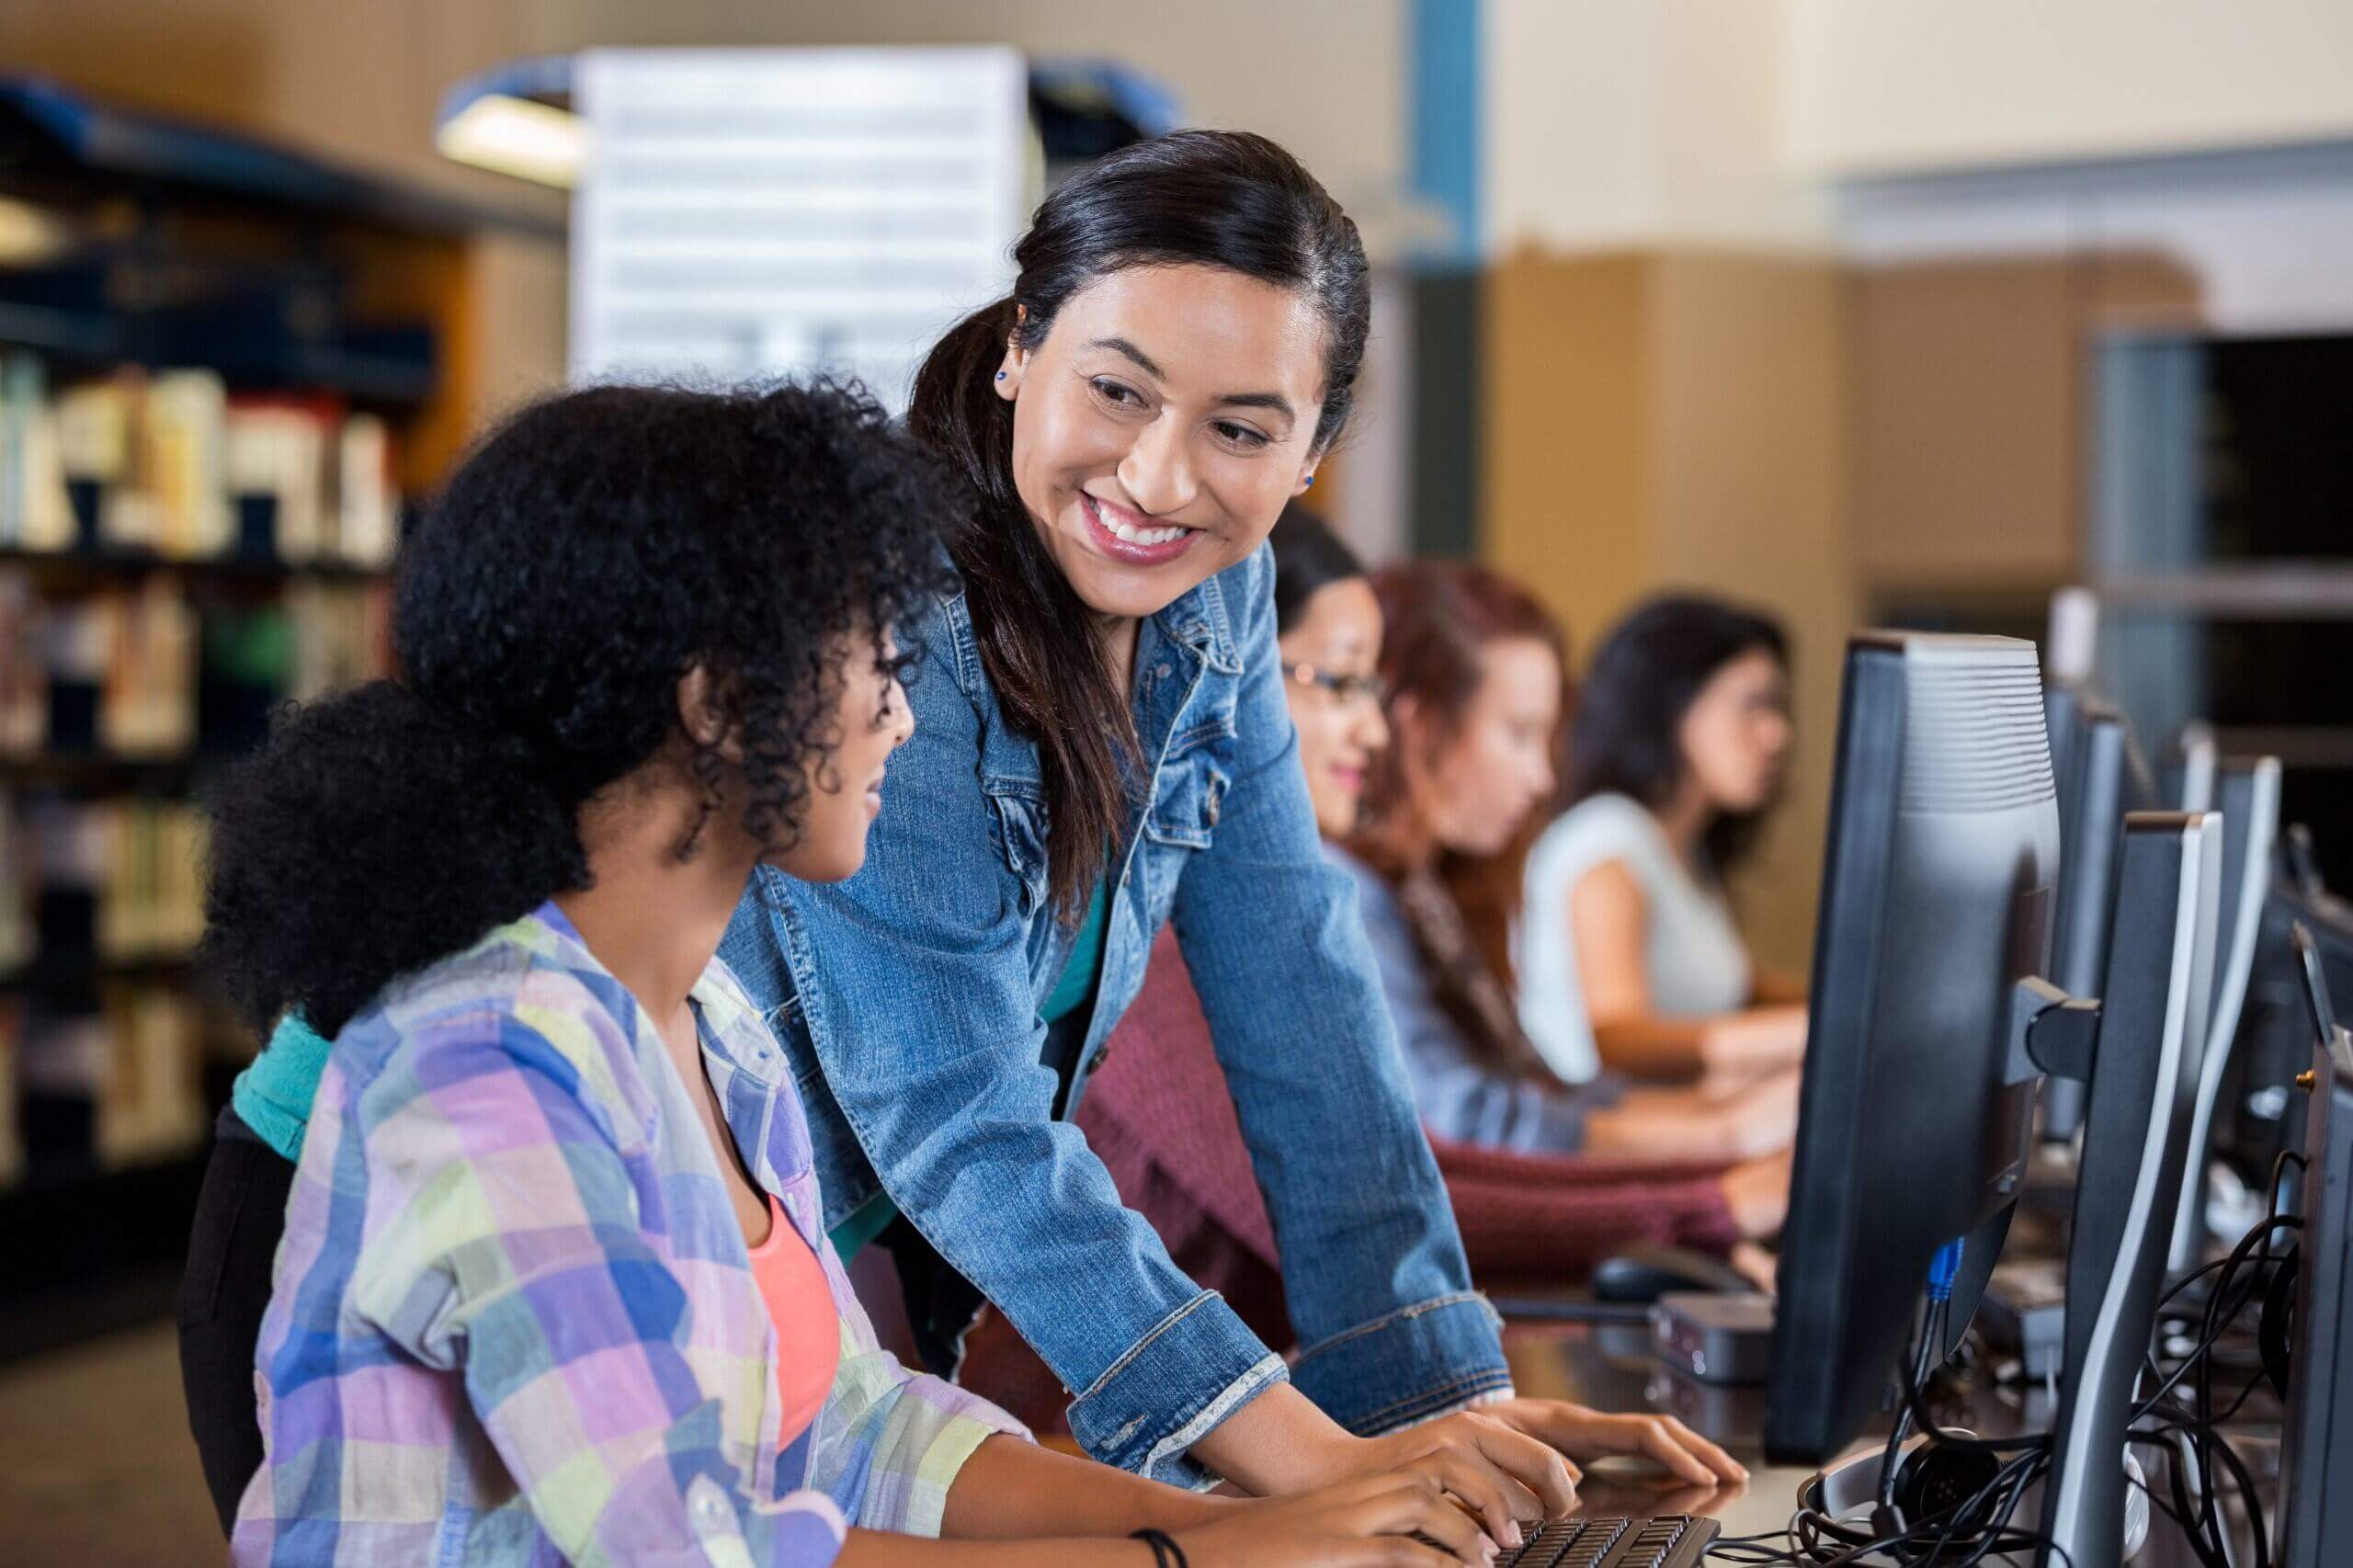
[{"x1": 2278, "y1": 930, "x2": 2353, "y2": 1563}]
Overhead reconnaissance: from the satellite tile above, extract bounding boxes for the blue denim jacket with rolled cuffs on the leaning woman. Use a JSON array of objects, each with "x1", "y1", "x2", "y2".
[{"x1": 720, "y1": 537, "x2": 1508, "y2": 1483}]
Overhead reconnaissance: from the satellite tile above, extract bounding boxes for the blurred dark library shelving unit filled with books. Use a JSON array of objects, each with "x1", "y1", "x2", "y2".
[{"x1": 0, "y1": 75, "x2": 563, "y2": 1361}]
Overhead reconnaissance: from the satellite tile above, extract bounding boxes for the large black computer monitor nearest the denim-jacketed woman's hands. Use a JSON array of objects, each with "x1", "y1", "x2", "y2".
[{"x1": 1765, "y1": 633, "x2": 2059, "y2": 1462}]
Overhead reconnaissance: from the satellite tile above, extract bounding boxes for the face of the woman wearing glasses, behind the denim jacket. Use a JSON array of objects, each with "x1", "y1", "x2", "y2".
[{"x1": 1282, "y1": 577, "x2": 1388, "y2": 838}]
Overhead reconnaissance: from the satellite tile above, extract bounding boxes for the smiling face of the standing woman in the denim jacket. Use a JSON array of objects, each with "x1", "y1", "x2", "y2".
[{"x1": 995, "y1": 266, "x2": 1324, "y2": 617}]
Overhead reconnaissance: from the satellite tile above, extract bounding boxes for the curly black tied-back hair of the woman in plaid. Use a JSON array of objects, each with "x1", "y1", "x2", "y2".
[{"x1": 205, "y1": 381, "x2": 972, "y2": 1036}]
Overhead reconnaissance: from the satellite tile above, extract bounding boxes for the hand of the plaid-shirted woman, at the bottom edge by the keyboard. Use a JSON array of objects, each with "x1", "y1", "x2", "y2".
[{"x1": 1174, "y1": 1462, "x2": 1496, "y2": 1568}]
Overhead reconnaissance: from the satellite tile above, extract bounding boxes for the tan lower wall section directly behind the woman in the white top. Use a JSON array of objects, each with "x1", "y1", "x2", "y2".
[{"x1": 1483, "y1": 250, "x2": 1857, "y2": 972}]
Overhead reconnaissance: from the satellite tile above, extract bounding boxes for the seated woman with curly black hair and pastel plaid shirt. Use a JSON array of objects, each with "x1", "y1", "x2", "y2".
[{"x1": 183, "y1": 386, "x2": 1492, "y2": 1568}]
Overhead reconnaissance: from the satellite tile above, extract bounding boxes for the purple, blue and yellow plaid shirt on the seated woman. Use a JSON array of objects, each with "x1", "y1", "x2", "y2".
[{"x1": 231, "y1": 904, "x2": 1021, "y2": 1565}]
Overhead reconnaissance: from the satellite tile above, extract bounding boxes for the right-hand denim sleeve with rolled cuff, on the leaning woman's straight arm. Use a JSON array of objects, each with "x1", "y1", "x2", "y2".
[{"x1": 1172, "y1": 551, "x2": 1511, "y2": 1434}]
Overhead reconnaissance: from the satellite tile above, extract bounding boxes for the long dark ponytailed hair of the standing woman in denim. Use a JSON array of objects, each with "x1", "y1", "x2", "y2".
[{"x1": 908, "y1": 131, "x2": 1371, "y2": 921}]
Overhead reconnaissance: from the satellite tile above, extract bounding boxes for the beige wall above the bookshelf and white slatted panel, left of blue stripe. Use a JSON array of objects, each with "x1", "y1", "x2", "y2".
[{"x1": 0, "y1": 0, "x2": 1404, "y2": 412}]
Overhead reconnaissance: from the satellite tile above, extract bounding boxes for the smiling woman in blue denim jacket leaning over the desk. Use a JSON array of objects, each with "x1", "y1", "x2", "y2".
[{"x1": 722, "y1": 131, "x2": 1732, "y2": 1516}]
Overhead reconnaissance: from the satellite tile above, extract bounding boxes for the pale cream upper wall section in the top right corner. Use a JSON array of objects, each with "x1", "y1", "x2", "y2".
[{"x1": 1786, "y1": 0, "x2": 2353, "y2": 175}]
